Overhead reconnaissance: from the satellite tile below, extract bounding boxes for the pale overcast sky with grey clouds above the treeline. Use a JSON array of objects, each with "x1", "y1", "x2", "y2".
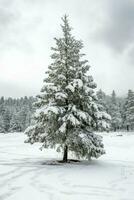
[{"x1": 0, "y1": 0, "x2": 134, "y2": 97}]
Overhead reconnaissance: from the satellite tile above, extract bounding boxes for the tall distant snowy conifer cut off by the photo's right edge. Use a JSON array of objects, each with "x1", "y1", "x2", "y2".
[{"x1": 123, "y1": 90, "x2": 134, "y2": 131}]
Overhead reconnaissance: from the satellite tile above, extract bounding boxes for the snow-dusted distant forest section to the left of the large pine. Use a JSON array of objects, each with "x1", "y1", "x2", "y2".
[{"x1": 0, "y1": 97, "x2": 35, "y2": 133}]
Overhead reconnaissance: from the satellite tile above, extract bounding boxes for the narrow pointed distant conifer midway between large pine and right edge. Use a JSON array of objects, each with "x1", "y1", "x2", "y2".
[{"x1": 109, "y1": 90, "x2": 122, "y2": 131}]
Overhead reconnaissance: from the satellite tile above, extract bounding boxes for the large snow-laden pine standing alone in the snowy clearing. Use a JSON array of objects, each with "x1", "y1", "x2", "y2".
[{"x1": 25, "y1": 15, "x2": 110, "y2": 162}]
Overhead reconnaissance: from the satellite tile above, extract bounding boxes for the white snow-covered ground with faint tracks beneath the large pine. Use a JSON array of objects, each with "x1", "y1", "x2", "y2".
[{"x1": 0, "y1": 133, "x2": 134, "y2": 200}]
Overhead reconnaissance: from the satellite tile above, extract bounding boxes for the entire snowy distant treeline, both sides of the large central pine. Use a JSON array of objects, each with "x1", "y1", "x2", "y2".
[{"x1": 0, "y1": 90, "x2": 134, "y2": 133}]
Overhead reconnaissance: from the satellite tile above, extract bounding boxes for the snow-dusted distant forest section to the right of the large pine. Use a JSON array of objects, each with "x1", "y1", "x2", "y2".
[{"x1": 97, "y1": 90, "x2": 134, "y2": 131}]
